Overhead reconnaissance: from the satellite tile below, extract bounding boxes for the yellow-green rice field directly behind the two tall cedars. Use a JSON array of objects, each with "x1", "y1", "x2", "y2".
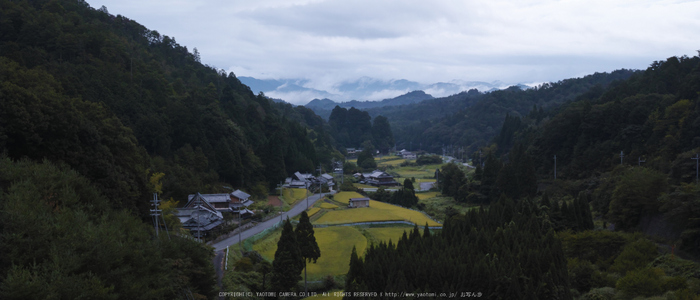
[{"x1": 253, "y1": 226, "x2": 367, "y2": 279}]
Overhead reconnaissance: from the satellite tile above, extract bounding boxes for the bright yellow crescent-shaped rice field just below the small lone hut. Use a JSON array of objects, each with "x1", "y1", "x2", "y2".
[{"x1": 314, "y1": 200, "x2": 442, "y2": 226}]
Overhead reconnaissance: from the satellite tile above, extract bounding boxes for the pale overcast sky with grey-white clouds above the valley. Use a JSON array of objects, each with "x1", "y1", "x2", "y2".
[{"x1": 87, "y1": 0, "x2": 700, "y2": 95}]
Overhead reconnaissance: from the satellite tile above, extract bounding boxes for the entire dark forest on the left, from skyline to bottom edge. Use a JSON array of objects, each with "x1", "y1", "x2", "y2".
[{"x1": 0, "y1": 0, "x2": 342, "y2": 299}]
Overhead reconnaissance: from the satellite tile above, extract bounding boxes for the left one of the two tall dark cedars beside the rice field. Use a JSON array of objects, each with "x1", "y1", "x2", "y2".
[{"x1": 272, "y1": 219, "x2": 304, "y2": 292}]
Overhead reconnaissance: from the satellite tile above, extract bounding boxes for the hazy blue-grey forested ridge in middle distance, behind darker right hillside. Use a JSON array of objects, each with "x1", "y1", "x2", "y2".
[{"x1": 367, "y1": 70, "x2": 634, "y2": 153}]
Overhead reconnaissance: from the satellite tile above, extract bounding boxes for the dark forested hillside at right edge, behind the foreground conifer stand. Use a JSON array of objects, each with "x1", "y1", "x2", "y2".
[{"x1": 482, "y1": 56, "x2": 700, "y2": 255}]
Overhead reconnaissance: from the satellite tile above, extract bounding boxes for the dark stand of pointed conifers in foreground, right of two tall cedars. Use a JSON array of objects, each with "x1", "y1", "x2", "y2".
[{"x1": 344, "y1": 198, "x2": 572, "y2": 299}]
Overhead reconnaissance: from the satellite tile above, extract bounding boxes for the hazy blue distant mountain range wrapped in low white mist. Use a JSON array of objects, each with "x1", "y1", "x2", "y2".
[{"x1": 238, "y1": 76, "x2": 528, "y2": 105}]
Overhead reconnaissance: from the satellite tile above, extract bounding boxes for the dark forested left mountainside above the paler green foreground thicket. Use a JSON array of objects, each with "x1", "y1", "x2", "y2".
[{"x1": 0, "y1": 0, "x2": 334, "y2": 209}]
